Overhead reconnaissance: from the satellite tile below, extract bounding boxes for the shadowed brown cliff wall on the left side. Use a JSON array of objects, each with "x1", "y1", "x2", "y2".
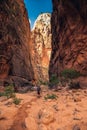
[{"x1": 0, "y1": 0, "x2": 33, "y2": 86}]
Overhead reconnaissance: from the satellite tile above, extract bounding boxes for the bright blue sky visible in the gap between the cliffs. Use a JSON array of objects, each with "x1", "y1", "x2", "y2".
[{"x1": 24, "y1": 0, "x2": 52, "y2": 28}]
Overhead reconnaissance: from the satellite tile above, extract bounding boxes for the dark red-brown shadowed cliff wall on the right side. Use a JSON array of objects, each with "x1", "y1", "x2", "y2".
[{"x1": 49, "y1": 0, "x2": 87, "y2": 86}]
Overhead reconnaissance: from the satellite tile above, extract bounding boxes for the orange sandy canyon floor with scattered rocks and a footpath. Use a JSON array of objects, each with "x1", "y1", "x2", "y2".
[{"x1": 0, "y1": 87, "x2": 87, "y2": 130}]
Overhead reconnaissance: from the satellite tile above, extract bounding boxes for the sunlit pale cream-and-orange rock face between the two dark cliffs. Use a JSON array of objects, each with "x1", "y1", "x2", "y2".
[{"x1": 31, "y1": 13, "x2": 51, "y2": 80}]
